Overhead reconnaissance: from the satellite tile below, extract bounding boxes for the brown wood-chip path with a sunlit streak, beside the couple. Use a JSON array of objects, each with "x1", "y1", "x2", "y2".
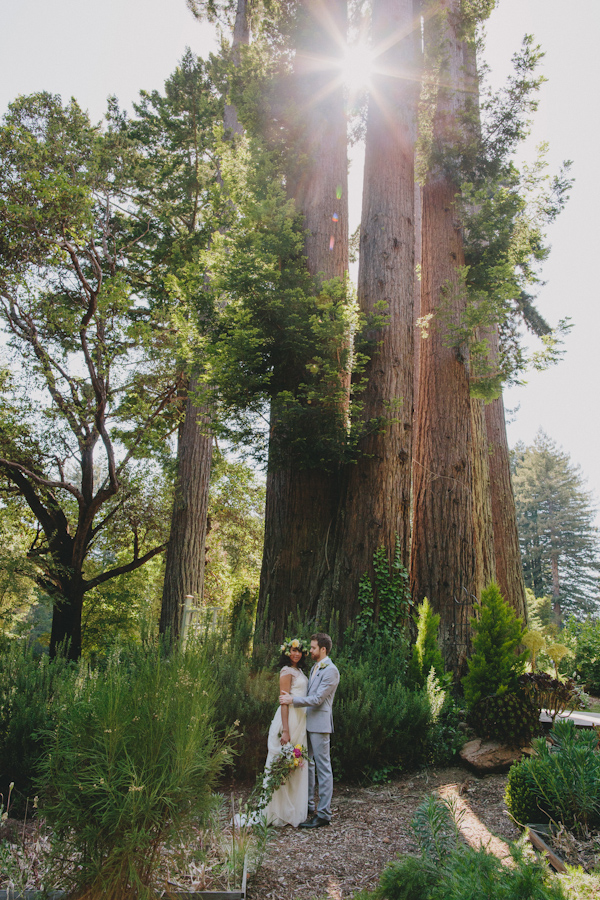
[{"x1": 248, "y1": 768, "x2": 518, "y2": 900}]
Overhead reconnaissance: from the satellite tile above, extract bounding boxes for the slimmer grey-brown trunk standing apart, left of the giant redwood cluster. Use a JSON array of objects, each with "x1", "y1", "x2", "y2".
[{"x1": 159, "y1": 376, "x2": 212, "y2": 639}]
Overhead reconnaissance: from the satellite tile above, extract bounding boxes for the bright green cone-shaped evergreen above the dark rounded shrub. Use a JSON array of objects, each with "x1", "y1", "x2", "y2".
[{"x1": 462, "y1": 581, "x2": 527, "y2": 708}]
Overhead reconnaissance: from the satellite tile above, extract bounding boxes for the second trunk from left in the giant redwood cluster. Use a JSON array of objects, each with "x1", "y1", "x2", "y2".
[{"x1": 319, "y1": 0, "x2": 420, "y2": 627}]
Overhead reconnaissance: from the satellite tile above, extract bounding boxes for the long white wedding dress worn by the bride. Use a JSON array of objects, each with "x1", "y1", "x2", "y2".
[{"x1": 265, "y1": 666, "x2": 308, "y2": 828}]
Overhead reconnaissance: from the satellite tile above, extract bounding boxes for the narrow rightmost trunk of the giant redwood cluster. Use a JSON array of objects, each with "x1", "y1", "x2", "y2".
[{"x1": 485, "y1": 328, "x2": 527, "y2": 622}]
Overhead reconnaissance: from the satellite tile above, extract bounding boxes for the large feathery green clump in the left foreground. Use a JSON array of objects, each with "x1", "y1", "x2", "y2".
[{"x1": 39, "y1": 647, "x2": 230, "y2": 900}]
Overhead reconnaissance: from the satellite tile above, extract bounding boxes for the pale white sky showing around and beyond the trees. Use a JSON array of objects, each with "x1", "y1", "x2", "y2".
[{"x1": 0, "y1": 0, "x2": 600, "y2": 522}]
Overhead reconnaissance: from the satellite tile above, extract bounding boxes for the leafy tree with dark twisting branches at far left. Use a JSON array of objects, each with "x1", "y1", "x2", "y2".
[{"x1": 0, "y1": 94, "x2": 176, "y2": 658}]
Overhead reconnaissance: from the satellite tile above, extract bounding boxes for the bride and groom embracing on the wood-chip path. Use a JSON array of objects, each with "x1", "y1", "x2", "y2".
[{"x1": 265, "y1": 633, "x2": 340, "y2": 828}]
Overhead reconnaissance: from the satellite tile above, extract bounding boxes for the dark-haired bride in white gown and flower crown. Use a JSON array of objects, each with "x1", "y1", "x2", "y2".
[{"x1": 265, "y1": 638, "x2": 308, "y2": 828}]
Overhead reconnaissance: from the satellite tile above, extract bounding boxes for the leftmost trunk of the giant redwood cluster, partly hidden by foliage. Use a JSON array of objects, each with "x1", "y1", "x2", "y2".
[{"x1": 257, "y1": 0, "x2": 348, "y2": 641}]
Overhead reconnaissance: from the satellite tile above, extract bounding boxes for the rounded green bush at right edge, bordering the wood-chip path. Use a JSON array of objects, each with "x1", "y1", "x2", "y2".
[{"x1": 507, "y1": 720, "x2": 600, "y2": 832}]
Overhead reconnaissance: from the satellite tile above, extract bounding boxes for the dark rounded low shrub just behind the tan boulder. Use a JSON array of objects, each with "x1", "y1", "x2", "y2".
[{"x1": 468, "y1": 691, "x2": 539, "y2": 747}]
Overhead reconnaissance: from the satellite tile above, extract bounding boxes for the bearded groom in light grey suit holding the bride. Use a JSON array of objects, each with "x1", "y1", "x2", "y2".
[{"x1": 279, "y1": 633, "x2": 340, "y2": 828}]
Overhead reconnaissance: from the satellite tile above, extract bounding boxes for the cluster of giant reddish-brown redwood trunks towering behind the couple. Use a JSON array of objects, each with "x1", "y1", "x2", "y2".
[{"x1": 163, "y1": 0, "x2": 525, "y2": 673}]
